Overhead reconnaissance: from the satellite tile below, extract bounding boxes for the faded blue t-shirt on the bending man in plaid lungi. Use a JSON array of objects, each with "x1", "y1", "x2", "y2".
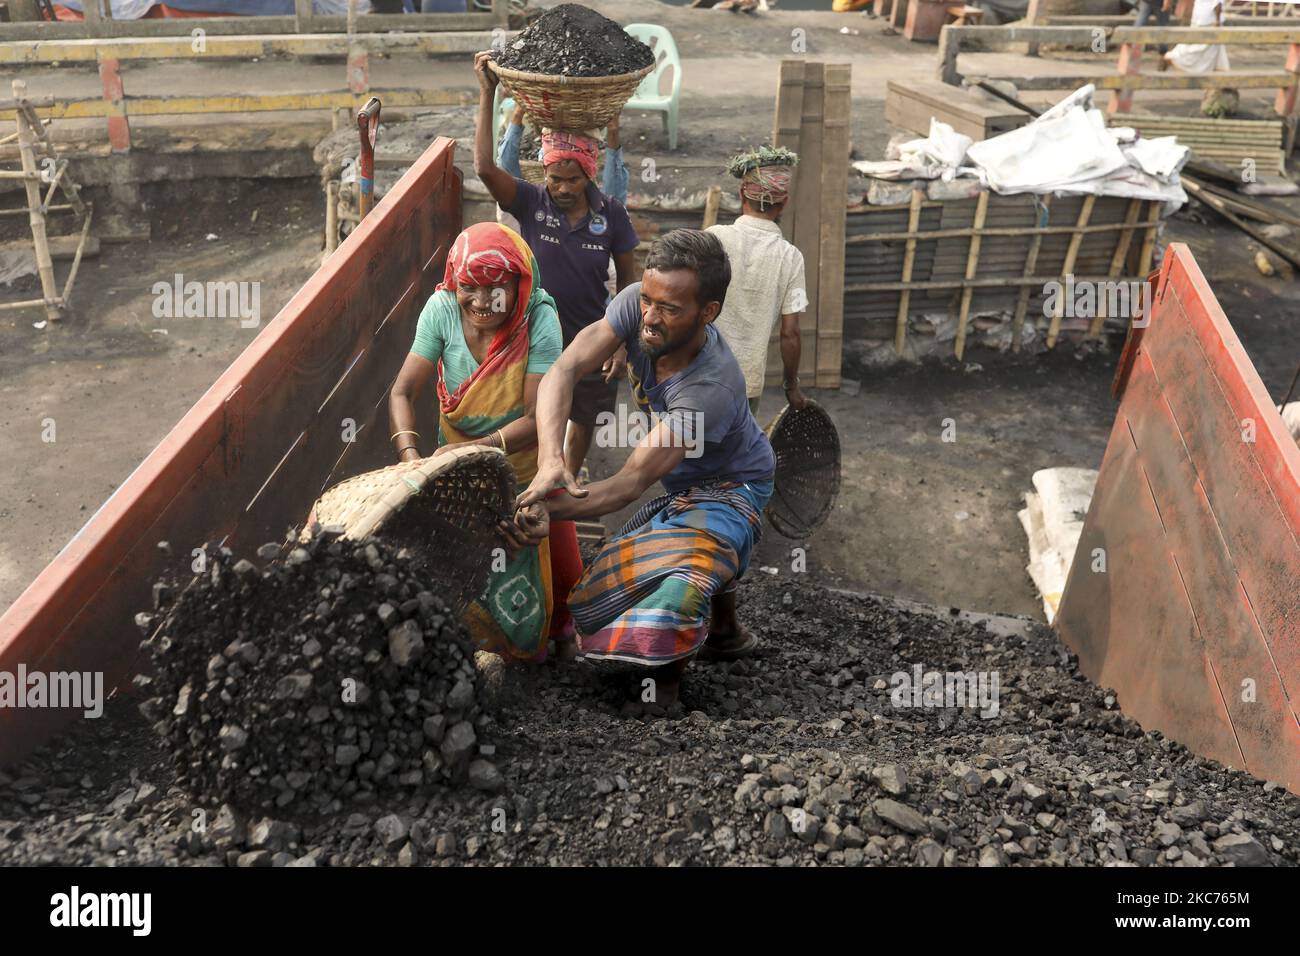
[{"x1": 606, "y1": 282, "x2": 776, "y2": 492}]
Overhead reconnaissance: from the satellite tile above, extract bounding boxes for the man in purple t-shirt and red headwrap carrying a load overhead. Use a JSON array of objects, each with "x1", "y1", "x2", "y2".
[{"x1": 475, "y1": 52, "x2": 637, "y2": 486}]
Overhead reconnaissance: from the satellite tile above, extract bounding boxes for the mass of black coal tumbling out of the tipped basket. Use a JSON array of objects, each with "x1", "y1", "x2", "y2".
[{"x1": 138, "y1": 536, "x2": 495, "y2": 812}]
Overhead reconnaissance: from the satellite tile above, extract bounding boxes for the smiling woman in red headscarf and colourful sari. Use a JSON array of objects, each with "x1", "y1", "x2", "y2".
[{"x1": 389, "y1": 222, "x2": 582, "y2": 661}]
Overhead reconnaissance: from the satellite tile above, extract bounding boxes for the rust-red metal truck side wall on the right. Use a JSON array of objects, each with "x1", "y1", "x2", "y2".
[{"x1": 1057, "y1": 243, "x2": 1300, "y2": 792}]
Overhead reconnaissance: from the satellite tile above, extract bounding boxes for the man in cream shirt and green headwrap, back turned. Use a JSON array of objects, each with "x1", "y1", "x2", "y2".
[{"x1": 709, "y1": 146, "x2": 807, "y2": 414}]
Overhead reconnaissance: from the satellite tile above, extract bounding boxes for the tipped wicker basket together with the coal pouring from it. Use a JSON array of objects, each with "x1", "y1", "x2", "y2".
[{"x1": 137, "y1": 449, "x2": 512, "y2": 813}]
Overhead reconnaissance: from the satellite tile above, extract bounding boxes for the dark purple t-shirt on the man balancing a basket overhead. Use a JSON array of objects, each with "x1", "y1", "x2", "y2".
[{"x1": 506, "y1": 179, "x2": 637, "y2": 345}]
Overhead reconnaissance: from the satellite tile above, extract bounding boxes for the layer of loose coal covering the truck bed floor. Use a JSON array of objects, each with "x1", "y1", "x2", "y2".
[{"x1": 0, "y1": 571, "x2": 1300, "y2": 868}]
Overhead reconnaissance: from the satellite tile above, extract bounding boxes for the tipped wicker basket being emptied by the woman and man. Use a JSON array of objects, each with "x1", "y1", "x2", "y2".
[{"x1": 302, "y1": 445, "x2": 515, "y2": 613}]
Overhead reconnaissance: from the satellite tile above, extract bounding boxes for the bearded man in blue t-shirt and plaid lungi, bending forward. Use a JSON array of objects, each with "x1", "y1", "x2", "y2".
[{"x1": 504, "y1": 229, "x2": 776, "y2": 705}]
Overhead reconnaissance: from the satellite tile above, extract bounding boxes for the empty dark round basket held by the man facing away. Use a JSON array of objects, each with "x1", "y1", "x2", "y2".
[{"x1": 767, "y1": 401, "x2": 840, "y2": 538}]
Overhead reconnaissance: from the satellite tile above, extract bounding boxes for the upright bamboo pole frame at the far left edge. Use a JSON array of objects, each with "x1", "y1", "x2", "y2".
[{"x1": 0, "y1": 79, "x2": 91, "y2": 321}]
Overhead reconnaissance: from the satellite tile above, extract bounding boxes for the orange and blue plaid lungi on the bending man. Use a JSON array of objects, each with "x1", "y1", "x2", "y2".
[{"x1": 569, "y1": 480, "x2": 772, "y2": 665}]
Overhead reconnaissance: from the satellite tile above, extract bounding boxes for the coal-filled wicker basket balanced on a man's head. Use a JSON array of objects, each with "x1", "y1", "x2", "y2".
[{"x1": 490, "y1": 4, "x2": 655, "y2": 130}]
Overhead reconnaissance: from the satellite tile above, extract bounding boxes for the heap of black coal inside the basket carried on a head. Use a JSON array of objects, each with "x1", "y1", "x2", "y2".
[{"x1": 494, "y1": 4, "x2": 654, "y2": 77}]
